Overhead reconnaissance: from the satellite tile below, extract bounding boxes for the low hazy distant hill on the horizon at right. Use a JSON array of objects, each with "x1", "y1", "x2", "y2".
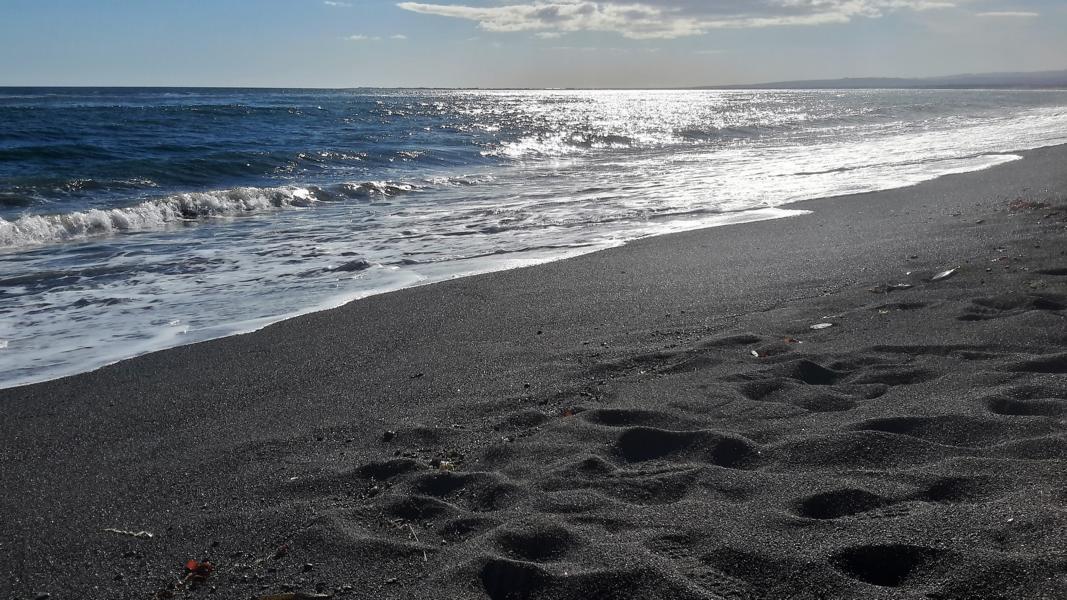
[{"x1": 700, "y1": 70, "x2": 1067, "y2": 90}]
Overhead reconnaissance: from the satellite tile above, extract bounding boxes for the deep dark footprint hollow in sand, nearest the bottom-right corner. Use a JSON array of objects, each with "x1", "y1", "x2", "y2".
[{"x1": 830, "y1": 543, "x2": 943, "y2": 587}]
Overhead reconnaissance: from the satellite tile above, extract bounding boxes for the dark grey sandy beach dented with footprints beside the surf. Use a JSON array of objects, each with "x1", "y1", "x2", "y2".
[{"x1": 0, "y1": 141, "x2": 1067, "y2": 599}]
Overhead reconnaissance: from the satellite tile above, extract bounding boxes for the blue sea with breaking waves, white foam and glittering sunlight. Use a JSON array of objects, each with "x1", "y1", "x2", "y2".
[{"x1": 0, "y1": 88, "x2": 1067, "y2": 386}]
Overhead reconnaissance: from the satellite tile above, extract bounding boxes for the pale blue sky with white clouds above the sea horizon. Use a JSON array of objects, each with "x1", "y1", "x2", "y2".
[{"x1": 0, "y1": 0, "x2": 1067, "y2": 88}]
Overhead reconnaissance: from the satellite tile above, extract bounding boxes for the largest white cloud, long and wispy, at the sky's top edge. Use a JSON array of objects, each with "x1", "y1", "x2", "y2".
[{"x1": 397, "y1": 0, "x2": 967, "y2": 40}]
